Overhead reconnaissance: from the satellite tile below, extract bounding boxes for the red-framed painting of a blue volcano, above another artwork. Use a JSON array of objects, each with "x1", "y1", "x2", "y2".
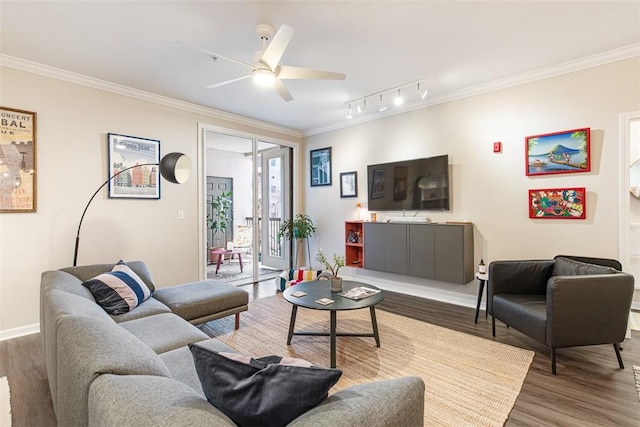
[{"x1": 525, "y1": 128, "x2": 591, "y2": 176}]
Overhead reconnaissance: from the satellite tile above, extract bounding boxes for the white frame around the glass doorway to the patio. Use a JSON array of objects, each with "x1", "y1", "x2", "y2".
[{"x1": 196, "y1": 122, "x2": 303, "y2": 280}]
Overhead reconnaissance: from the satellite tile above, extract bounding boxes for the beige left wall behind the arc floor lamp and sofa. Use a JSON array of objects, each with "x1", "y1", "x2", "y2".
[{"x1": 0, "y1": 67, "x2": 299, "y2": 338}]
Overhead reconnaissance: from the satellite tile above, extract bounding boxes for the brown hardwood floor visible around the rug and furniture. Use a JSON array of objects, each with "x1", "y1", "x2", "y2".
[{"x1": 0, "y1": 281, "x2": 640, "y2": 427}]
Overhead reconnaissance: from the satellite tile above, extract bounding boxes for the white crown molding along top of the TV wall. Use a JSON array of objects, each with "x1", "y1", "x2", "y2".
[{"x1": 302, "y1": 43, "x2": 640, "y2": 138}]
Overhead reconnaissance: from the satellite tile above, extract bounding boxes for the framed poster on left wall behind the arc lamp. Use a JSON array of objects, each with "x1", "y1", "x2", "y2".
[{"x1": 108, "y1": 133, "x2": 160, "y2": 199}]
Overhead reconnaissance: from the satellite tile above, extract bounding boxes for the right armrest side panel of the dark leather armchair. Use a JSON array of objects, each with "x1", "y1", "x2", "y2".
[{"x1": 547, "y1": 273, "x2": 634, "y2": 348}]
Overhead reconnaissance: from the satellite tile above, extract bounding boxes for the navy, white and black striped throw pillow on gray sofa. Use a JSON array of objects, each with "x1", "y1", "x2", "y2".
[{"x1": 83, "y1": 261, "x2": 151, "y2": 314}]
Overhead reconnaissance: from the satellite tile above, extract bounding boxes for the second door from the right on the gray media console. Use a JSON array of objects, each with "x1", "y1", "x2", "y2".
[{"x1": 409, "y1": 224, "x2": 436, "y2": 279}]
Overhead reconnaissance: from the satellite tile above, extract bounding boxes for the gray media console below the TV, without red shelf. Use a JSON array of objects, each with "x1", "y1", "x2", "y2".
[{"x1": 364, "y1": 222, "x2": 474, "y2": 285}]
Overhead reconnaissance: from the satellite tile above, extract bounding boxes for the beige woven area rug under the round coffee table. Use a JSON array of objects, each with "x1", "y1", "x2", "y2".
[{"x1": 216, "y1": 295, "x2": 534, "y2": 426}]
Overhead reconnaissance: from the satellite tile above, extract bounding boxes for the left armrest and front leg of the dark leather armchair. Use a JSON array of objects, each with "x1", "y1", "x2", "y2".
[{"x1": 487, "y1": 260, "x2": 554, "y2": 313}]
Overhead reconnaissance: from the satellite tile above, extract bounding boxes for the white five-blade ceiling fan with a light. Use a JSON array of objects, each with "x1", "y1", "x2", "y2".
[{"x1": 174, "y1": 24, "x2": 346, "y2": 101}]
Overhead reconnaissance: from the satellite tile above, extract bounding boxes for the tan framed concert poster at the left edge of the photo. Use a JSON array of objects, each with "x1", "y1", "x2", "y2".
[{"x1": 0, "y1": 107, "x2": 38, "y2": 213}]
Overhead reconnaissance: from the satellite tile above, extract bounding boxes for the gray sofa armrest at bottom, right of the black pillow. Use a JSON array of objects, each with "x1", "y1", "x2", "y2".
[{"x1": 289, "y1": 377, "x2": 424, "y2": 427}]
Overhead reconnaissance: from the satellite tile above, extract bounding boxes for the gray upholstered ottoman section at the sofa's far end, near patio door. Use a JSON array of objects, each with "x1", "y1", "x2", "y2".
[{"x1": 153, "y1": 280, "x2": 249, "y2": 329}]
